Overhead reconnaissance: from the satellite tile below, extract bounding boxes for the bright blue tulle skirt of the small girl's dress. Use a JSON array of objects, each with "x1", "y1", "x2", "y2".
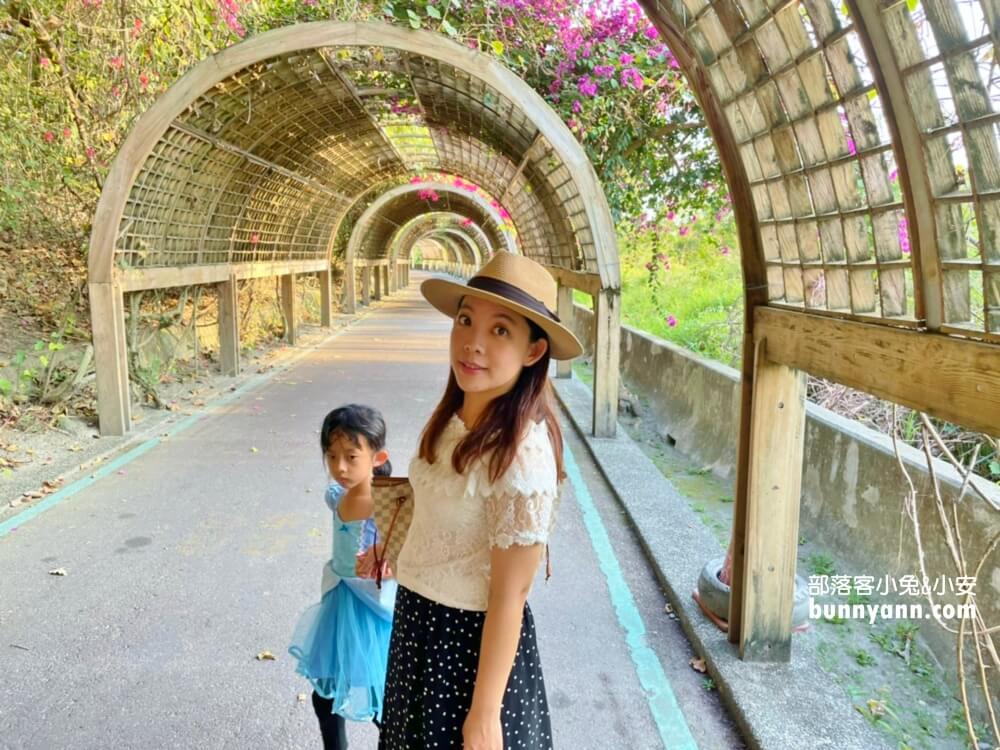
[{"x1": 288, "y1": 580, "x2": 395, "y2": 721}]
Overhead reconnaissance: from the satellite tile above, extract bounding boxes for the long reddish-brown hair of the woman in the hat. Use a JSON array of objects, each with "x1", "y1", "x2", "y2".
[{"x1": 420, "y1": 318, "x2": 565, "y2": 482}]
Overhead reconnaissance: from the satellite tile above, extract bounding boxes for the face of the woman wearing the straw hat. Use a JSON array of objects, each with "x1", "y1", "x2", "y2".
[{"x1": 451, "y1": 296, "x2": 548, "y2": 399}]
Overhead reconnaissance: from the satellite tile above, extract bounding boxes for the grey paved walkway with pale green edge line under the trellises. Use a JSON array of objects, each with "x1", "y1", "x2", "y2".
[{"x1": 0, "y1": 274, "x2": 740, "y2": 750}]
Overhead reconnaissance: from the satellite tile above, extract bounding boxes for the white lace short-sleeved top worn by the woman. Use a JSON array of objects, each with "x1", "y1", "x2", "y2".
[{"x1": 396, "y1": 416, "x2": 559, "y2": 612}]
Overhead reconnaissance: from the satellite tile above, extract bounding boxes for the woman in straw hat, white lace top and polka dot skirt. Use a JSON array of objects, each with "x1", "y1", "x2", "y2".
[{"x1": 379, "y1": 253, "x2": 581, "y2": 750}]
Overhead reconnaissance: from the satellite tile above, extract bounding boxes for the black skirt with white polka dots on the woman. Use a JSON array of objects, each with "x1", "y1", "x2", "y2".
[{"x1": 378, "y1": 586, "x2": 552, "y2": 750}]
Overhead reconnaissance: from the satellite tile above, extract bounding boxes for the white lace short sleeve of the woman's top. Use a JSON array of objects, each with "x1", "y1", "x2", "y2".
[{"x1": 486, "y1": 423, "x2": 558, "y2": 549}]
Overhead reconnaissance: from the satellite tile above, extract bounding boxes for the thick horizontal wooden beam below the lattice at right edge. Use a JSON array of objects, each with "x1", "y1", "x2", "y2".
[{"x1": 754, "y1": 308, "x2": 1000, "y2": 435}]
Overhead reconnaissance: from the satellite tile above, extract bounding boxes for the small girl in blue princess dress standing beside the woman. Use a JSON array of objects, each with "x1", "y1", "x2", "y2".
[{"x1": 288, "y1": 404, "x2": 396, "y2": 750}]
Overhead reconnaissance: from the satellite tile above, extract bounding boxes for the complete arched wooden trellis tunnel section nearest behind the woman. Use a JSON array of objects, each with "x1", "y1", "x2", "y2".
[{"x1": 88, "y1": 22, "x2": 620, "y2": 435}]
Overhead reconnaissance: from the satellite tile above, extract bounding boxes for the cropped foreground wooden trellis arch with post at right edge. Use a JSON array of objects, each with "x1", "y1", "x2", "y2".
[{"x1": 640, "y1": 0, "x2": 1000, "y2": 660}]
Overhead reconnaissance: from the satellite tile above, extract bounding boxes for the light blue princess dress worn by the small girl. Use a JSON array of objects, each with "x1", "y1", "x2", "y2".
[{"x1": 288, "y1": 484, "x2": 397, "y2": 721}]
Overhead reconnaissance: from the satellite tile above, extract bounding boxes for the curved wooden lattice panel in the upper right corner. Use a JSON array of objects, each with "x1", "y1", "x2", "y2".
[{"x1": 645, "y1": 0, "x2": 1000, "y2": 338}]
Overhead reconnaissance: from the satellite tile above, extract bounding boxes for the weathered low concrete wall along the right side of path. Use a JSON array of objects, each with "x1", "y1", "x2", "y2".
[{"x1": 574, "y1": 305, "x2": 1000, "y2": 690}]
